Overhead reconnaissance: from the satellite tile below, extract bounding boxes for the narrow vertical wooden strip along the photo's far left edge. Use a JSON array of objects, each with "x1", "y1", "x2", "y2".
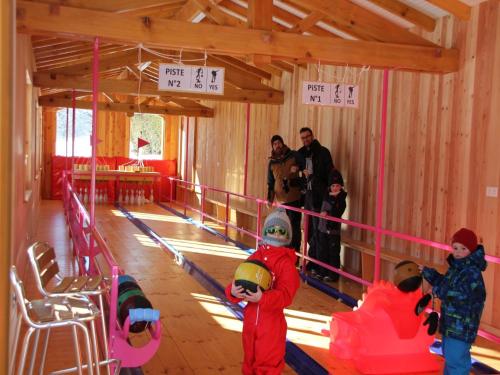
[{"x1": 0, "y1": 1, "x2": 14, "y2": 374}]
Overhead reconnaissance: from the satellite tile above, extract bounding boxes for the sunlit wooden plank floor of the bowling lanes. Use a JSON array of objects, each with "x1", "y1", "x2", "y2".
[{"x1": 21, "y1": 201, "x2": 500, "y2": 374}]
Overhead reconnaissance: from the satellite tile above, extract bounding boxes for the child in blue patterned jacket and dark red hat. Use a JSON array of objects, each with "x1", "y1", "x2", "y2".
[{"x1": 422, "y1": 228, "x2": 487, "y2": 375}]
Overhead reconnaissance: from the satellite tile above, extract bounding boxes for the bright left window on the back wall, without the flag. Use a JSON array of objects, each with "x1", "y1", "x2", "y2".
[{"x1": 56, "y1": 108, "x2": 92, "y2": 156}]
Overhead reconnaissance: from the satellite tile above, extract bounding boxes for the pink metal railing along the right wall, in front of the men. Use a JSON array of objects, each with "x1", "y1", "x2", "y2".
[{"x1": 167, "y1": 177, "x2": 500, "y2": 343}]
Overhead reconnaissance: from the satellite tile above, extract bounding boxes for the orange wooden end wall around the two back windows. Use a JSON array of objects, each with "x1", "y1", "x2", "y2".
[{"x1": 42, "y1": 108, "x2": 180, "y2": 199}]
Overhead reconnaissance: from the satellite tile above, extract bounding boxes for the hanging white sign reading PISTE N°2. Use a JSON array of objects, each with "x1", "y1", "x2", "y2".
[{"x1": 158, "y1": 64, "x2": 224, "y2": 95}]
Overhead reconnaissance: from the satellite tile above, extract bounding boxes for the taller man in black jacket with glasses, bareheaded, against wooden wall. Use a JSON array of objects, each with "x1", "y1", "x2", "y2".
[{"x1": 298, "y1": 128, "x2": 333, "y2": 271}]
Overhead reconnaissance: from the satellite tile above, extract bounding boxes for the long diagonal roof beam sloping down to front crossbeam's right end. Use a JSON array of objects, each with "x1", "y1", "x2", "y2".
[{"x1": 288, "y1": 0, "x2": 436, "y2": 47}]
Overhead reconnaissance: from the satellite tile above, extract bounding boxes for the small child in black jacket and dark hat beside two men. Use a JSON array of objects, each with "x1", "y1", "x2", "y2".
[{"x1": 312, "y1": 169, "x2": 347, "y2": 281}]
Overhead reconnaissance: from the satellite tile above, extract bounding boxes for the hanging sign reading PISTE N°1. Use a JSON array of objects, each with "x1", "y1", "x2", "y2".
[{"x1": 302, "y1": 81, "x2": 359, "y2": 108}]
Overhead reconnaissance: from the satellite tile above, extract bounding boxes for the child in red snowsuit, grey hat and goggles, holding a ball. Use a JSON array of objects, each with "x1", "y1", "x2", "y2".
[{"x1": 226, "y1": 211, "x2": 299, "y2": 375}]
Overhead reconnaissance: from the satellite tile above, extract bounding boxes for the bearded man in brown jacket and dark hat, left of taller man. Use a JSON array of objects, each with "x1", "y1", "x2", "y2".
[{"x1": 267, "y1": 135, "x2": 305, "y2": 252}]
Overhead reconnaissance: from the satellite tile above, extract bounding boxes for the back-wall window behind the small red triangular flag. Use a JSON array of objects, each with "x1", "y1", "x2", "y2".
[{"x1": 129, "y1": 113, "x2": 165, "y2": 159}]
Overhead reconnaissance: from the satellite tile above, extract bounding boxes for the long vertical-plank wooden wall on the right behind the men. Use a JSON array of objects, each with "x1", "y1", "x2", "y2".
[{"x1": 190, "y1": 0, "x2": 500, "y2": 332}]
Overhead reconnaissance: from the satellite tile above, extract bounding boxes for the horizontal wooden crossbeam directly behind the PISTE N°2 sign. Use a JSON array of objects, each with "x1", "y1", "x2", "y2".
[{"x1": 33, "y1": 73, "x2": 284, "y2": 104}]
